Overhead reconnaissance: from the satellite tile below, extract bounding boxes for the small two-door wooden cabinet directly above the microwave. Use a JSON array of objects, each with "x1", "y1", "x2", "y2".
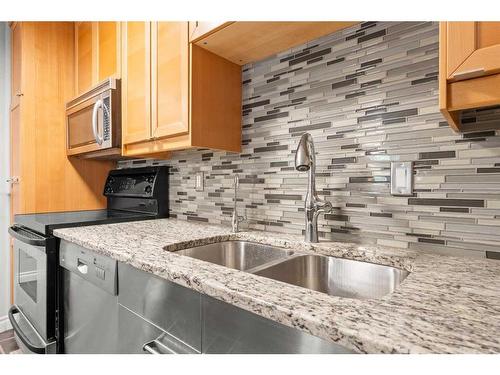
[{"x1": 75, "y1": 22, "x2": 120, "y2": 94}]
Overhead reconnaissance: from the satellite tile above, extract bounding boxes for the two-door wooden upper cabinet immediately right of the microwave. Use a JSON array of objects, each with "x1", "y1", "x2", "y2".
[{"x1": 122, "y1": 22, "x2": 241, "y2": 157}]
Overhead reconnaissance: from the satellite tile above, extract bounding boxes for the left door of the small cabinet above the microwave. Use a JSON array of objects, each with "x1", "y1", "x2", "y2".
[{"x1": 75, "y1": 22, "x2": 95, "y2": 94}]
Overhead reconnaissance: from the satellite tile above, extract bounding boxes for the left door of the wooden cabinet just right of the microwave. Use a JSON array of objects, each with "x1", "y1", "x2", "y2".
[{"x1": 121, "y1": 22, "x2": 151, "y2": 144}]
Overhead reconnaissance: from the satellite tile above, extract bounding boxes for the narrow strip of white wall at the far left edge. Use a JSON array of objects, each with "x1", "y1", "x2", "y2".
[{"x1": 0, "y1": 22, "x2": 10, "y2": 332}]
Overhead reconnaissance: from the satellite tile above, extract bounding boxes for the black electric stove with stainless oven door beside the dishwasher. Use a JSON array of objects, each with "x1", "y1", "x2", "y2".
[{"x1": 9, "y1": 166, "x2": 169, "y2": 353}]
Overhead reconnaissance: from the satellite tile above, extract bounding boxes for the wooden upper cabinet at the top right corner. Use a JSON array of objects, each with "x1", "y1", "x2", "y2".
[{"x1": 439, "y1": 22, "x2": 500, "y2": 131}]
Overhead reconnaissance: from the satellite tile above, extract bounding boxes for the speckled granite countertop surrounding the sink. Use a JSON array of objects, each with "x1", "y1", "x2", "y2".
[{"x1": 54, "y1": 219, "x2": 500, "y2": 353}]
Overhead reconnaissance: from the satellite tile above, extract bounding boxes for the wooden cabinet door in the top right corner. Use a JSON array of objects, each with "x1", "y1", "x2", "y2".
[{"x1": 446, "y1": 22, "x2": 500, "y2": 81}]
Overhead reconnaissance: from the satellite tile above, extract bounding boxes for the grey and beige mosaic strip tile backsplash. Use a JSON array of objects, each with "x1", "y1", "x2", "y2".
[{"x1": 121, "y1": 22, "x2": 500, "y2": 256}]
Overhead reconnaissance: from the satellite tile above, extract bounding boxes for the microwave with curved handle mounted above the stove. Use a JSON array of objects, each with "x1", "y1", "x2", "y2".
[{"x1": 66, "y1": 78, "x2": 121, "y2": 159}]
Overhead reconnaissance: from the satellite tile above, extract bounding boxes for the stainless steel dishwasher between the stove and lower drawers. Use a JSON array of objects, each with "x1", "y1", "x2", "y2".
[{"x1": 59, "y1": 241, "x2": 118, "y2": 354}]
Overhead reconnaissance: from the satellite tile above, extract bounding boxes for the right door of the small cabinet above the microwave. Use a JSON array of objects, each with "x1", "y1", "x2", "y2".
[{"x1": 97, "y1": 22, "x2": 120, "y2": 82}]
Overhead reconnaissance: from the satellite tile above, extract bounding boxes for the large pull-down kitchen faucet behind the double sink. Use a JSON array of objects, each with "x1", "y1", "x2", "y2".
[{"x1": 295, "y1": 133, "x2": 332, "y2": 242}]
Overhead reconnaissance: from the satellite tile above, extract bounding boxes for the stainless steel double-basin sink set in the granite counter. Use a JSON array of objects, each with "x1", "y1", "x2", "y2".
[{"x1": 170, "y1": 241, "x2": 409, "y2": 299}]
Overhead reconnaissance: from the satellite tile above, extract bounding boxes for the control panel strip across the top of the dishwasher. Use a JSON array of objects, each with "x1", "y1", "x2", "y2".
[{"x1": 59, "y1": 240, "x2": 118, "y2": 296}]
